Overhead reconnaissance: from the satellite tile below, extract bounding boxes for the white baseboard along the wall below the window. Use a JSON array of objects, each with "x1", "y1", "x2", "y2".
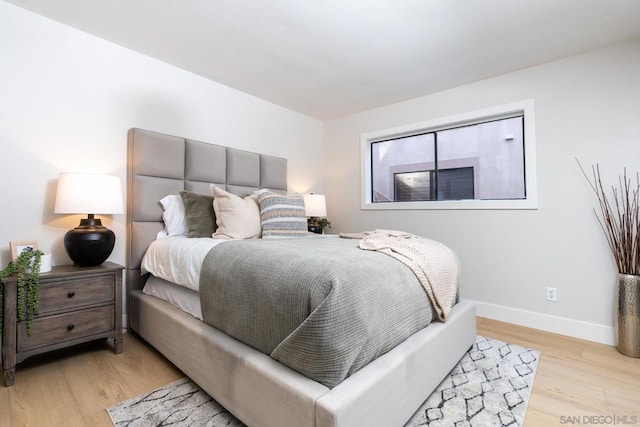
[{"x1": 475, "y1": 301, "x2": 616, "y2": 345}]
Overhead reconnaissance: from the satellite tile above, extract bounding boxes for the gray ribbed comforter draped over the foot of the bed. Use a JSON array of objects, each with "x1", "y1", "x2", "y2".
[{"x1": 200, "y1": 237, "x2": 444, "y2": 387}]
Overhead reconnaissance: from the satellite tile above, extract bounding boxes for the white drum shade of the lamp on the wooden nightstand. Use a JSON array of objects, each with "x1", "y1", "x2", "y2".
[{"x1": 54, "y1": 173, "x2": 124, "y2": 214}]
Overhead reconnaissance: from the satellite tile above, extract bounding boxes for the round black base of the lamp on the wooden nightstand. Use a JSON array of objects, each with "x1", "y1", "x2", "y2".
[{"x1": 64, "y1": 215, "x2": 116, "y2": 267}]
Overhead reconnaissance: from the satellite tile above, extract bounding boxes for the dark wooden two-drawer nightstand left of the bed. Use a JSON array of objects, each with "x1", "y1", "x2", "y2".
[{"x1": 2, "y1": 262, "x2": 124, "y2": 386}]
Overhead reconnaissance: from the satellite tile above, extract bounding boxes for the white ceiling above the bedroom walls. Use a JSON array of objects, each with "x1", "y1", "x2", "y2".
[{"x1": 8, "y1": 0, "x2": 640, "y2": 120}]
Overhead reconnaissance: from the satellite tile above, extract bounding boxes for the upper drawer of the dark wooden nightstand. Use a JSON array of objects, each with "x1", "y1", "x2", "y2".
[{"x1": 40, "y1": 276, "x2": 115, "y2": 315}]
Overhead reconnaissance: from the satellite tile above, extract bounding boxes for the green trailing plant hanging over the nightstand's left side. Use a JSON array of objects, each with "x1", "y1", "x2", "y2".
[{"x1": 0, "y1": 248, "x2": 43, "y2": 335}]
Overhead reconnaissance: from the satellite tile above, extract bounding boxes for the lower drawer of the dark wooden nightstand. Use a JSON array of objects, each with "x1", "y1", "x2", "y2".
[{"x1": 17, "y1": 305, "x2": 115, "y2": 352}]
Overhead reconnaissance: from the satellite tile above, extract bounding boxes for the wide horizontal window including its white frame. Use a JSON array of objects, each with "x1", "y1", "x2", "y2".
[{"x1": 362, "y1": 101, "x2": 536, "y2": 209}]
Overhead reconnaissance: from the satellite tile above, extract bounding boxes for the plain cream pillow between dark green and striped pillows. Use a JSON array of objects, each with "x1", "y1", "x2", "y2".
[{"x1": 209, "y1": 184, "x2": 260, "y2": 239}]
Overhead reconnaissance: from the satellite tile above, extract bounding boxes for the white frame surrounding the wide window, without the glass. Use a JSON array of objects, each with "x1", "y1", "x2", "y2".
[{"x1": 360, "y1": 99, "x2": 538, "y2": 210}]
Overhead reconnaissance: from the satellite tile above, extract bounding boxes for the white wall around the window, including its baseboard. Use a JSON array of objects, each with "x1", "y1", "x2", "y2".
[{"x1": 325, "y1": 40, "x2": 640, "y2": 343}]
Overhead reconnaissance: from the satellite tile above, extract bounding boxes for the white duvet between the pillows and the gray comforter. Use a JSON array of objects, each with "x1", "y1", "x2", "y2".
[{"x1": 141, "y1": 236, "x2": 228, "y2": 292}]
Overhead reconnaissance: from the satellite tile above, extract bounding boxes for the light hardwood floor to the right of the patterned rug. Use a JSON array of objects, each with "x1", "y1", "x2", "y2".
[{"x1": 478, "y1": 318, "x2": 640, "y2": 426}]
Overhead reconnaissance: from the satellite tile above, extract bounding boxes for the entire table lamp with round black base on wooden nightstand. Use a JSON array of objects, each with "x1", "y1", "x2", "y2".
[{"x1": 54, "y1": 173, "x2": 124, "y2": 267}]
